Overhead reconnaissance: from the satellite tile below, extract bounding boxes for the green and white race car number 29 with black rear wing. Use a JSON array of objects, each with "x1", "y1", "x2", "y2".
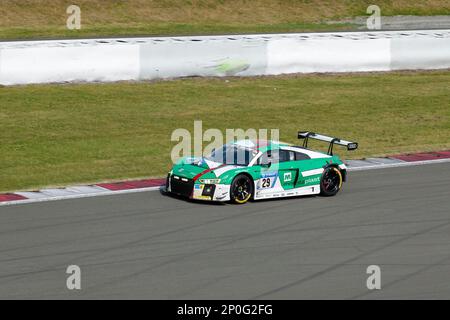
[{"x1": 166, "y1": 132, "x2": 358, "y2": 204}]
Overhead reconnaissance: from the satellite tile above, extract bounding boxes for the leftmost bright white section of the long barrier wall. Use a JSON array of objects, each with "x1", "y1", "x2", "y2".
[{"x1": 0, "y1": 45, "x2": 140, "y2": 85}]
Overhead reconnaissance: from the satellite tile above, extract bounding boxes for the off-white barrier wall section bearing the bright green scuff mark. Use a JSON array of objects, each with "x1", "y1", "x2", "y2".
[{"x1": 139, "y1": 39, "x2": 267, "y2": 80}]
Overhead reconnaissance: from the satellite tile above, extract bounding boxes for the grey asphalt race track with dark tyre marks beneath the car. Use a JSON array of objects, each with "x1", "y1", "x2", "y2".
[{"x1": 0, "y1": 163, "x2": 450, "y2": 299}]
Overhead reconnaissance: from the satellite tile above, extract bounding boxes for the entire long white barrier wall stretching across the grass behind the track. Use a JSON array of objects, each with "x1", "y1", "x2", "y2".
[{"x1": 0, "y1": 30, "x2": 450, "y2": 85}]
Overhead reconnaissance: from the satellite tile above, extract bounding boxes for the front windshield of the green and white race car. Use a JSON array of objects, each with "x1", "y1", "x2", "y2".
[{"x1": 206, "y1": 144, "x2": 257, "y2": 166}]
